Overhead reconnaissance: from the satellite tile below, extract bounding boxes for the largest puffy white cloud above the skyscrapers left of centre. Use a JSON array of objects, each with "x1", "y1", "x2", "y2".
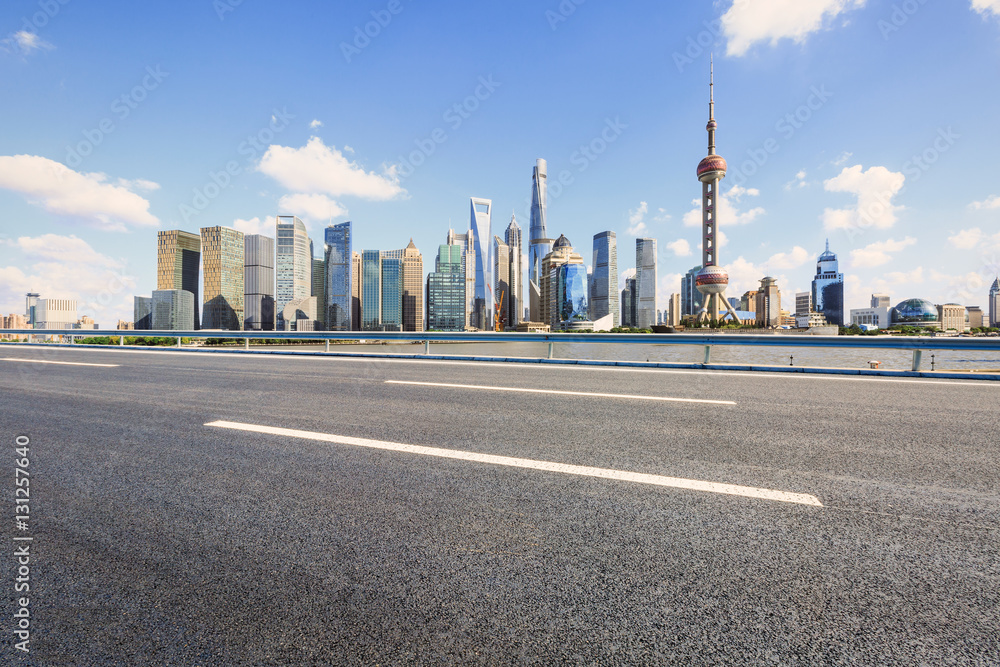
[{"x1": 257, "y1": 137, "x2": 406, "y2": 201}]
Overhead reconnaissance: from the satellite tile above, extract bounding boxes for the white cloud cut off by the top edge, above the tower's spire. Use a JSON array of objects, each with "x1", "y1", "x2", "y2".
[{"x1": 722, "y1": 0, "x2": 866, "y2": 56}]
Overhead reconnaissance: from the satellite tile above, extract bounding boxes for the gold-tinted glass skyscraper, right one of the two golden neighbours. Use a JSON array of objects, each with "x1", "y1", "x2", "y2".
[{"x1": 199, "y1": 227, "x2": 244, "y2": 331}]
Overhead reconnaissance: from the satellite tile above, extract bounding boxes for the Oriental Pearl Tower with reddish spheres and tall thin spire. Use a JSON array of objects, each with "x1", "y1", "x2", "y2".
[{"x1": 695, "y1": 60, "x2": 739, "y2": 323}]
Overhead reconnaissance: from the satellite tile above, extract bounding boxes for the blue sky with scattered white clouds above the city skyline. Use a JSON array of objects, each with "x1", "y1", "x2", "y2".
[{"x1": 0, "y1": 0, "x2": 1000, "y2": 326}]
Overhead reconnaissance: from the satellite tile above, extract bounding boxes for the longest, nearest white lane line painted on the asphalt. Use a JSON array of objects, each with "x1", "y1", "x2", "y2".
[{"x1": 205, "y1": 421, "x2": 823, "y2": 507}]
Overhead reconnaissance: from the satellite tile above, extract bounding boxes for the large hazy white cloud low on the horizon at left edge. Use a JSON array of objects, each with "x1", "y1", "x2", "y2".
[{"x1": 0, "y1": 234, "x2": 135, "y2": 328}]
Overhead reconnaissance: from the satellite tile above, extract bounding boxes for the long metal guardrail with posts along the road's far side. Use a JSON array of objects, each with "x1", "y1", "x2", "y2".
[{"x1": 0, "y1": 329, "x2": 1000, "y2": 371}]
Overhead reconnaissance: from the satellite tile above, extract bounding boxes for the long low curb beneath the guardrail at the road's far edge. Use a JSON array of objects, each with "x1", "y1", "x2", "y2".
[{"x1": 7, "y1": 342, "x2": 1000, "y2": 382}]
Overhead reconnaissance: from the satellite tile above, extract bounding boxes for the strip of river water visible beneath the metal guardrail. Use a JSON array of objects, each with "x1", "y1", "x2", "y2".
[{"x1": 248, "y1": 341, "x2": 1000, "y2": 372}]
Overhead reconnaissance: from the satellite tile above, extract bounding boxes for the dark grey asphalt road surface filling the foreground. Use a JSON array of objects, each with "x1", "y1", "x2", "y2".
[{"x1": 0, "y1": 346, "x2": 1000, "y2": 665}]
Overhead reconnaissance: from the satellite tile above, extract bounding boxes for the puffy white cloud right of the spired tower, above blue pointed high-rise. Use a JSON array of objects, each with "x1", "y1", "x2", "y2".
[{"x1": 823, "y1": 164, "x2": 906, "y2": 230}]
